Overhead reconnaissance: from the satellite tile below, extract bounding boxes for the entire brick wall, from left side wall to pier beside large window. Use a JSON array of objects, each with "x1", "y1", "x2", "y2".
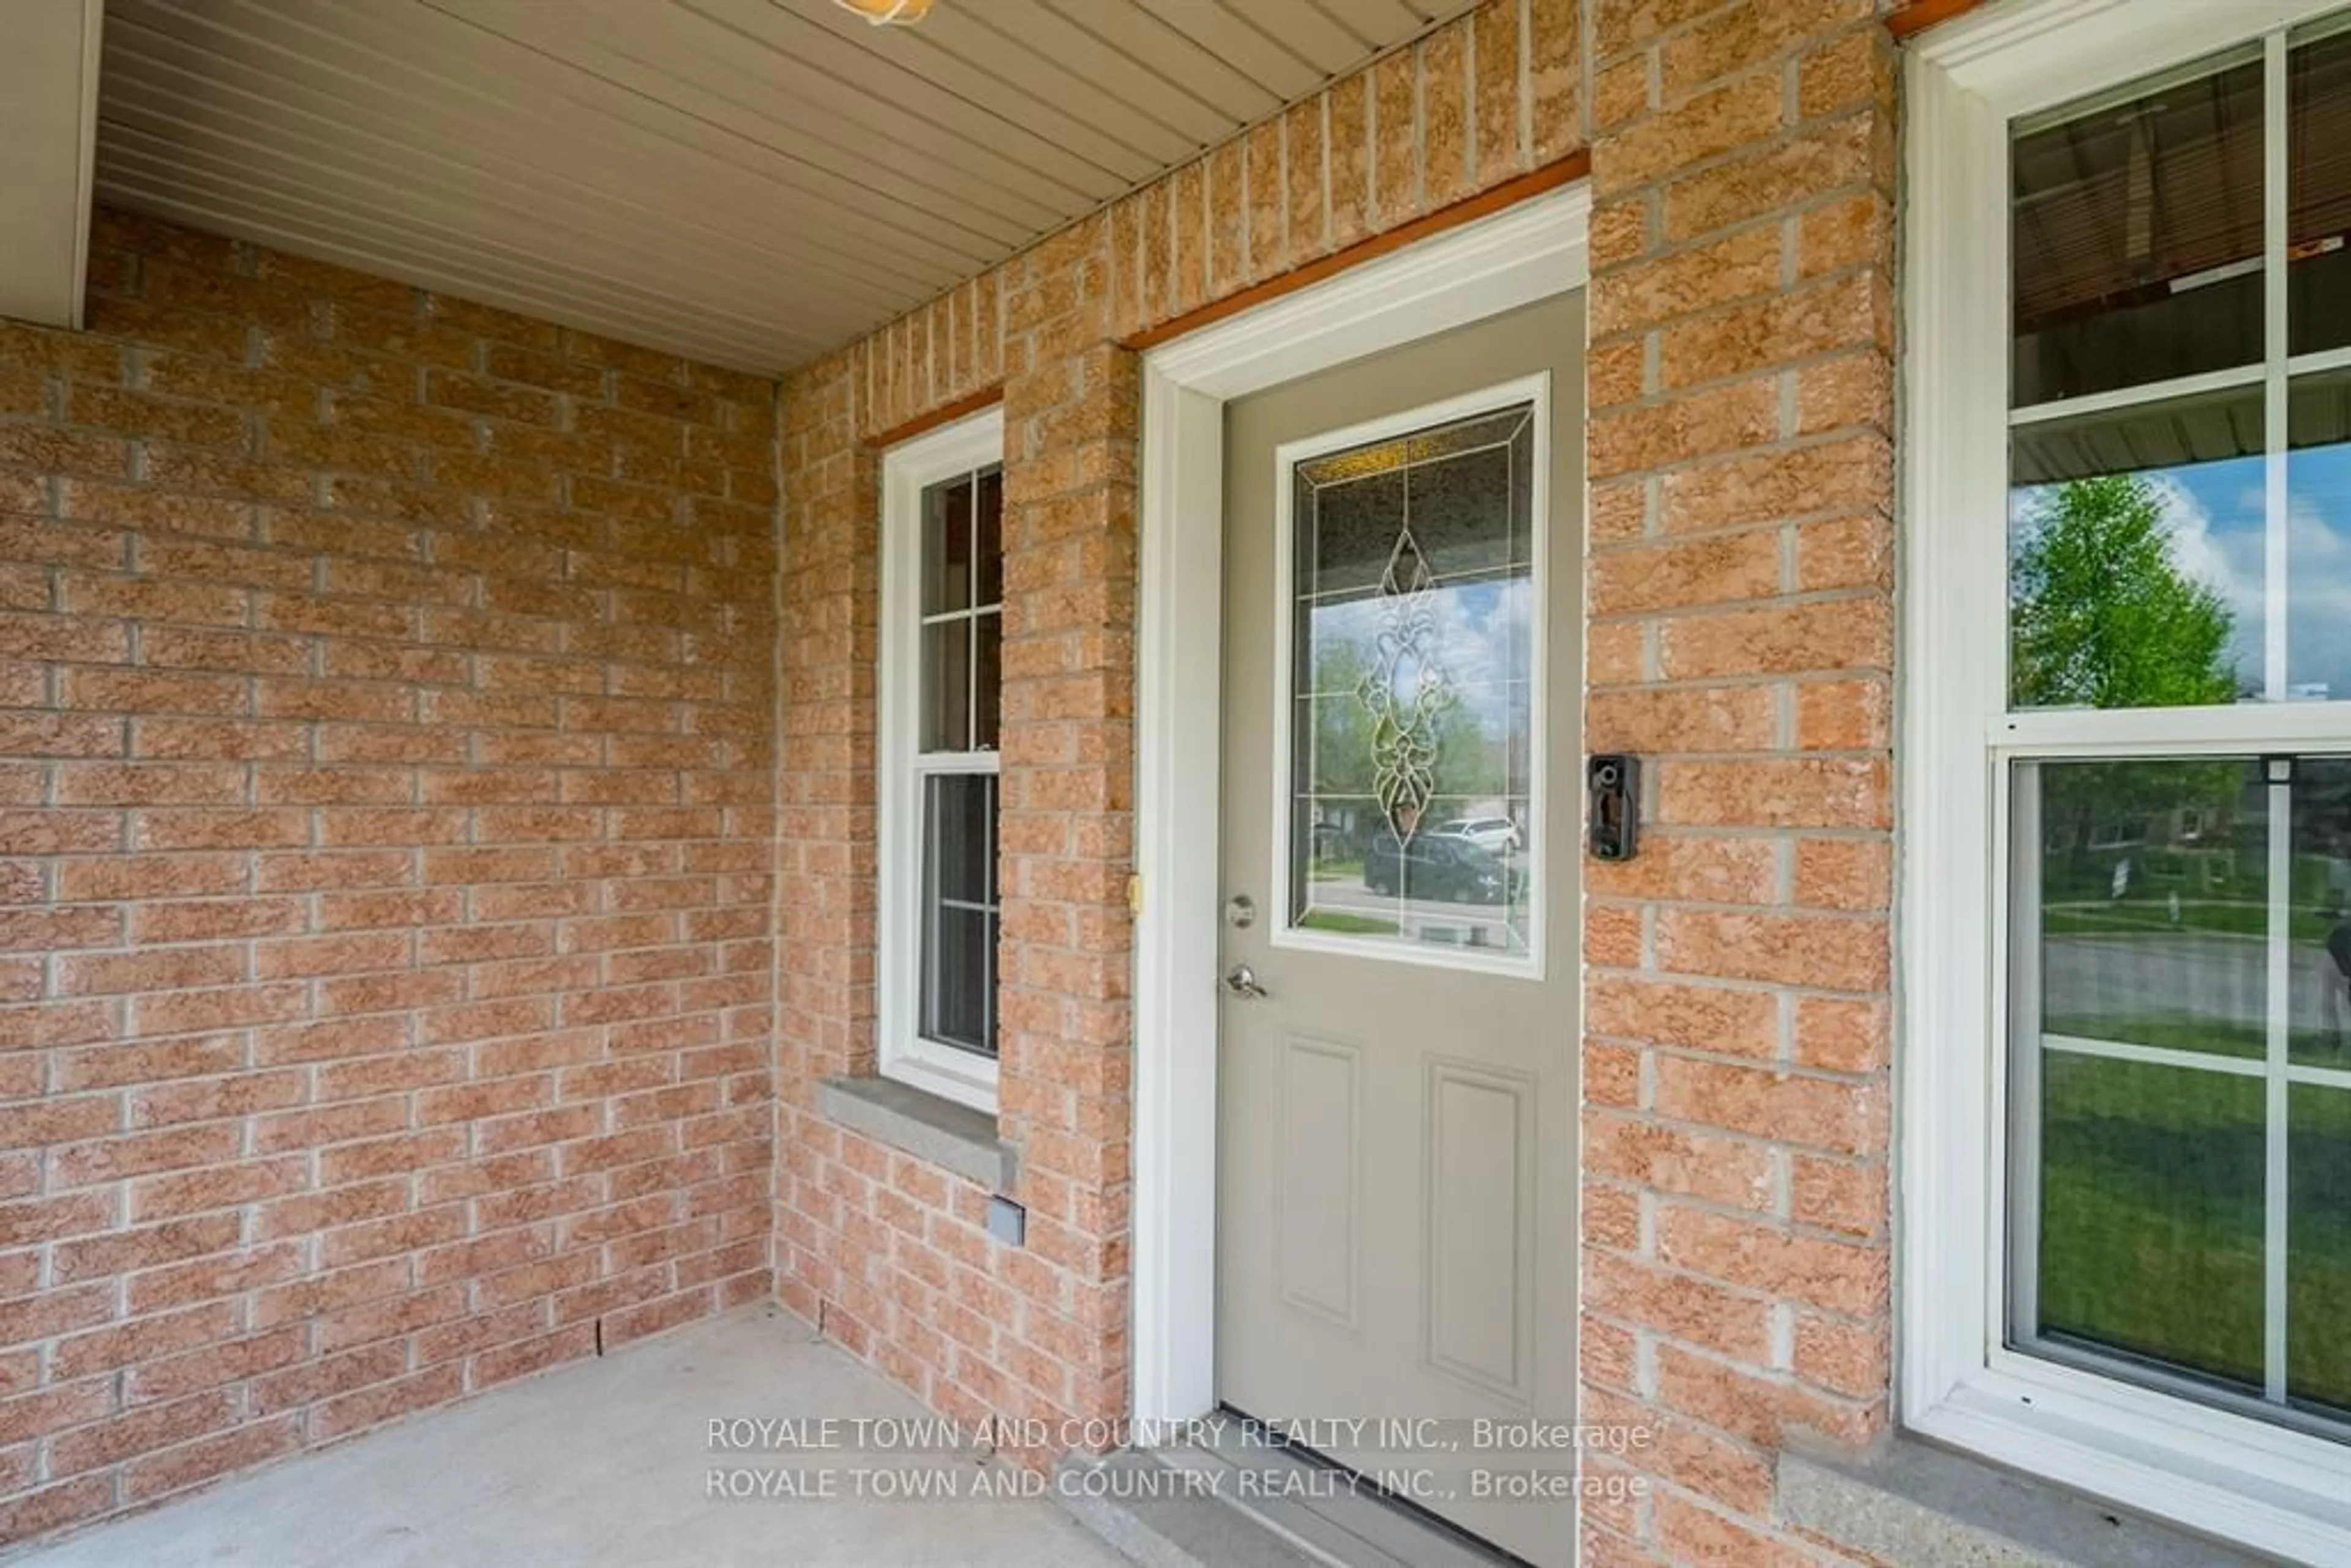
[{"x1": 0, "y1": 0, "x2": 1895, "y2": 1563}]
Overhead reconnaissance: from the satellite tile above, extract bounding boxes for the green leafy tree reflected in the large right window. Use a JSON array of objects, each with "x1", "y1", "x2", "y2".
[{"x1": 2010, "y1": 475, "x2": 2238, "y2": 708}]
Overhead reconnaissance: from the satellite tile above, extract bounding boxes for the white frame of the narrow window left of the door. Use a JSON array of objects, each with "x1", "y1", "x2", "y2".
[{"x1": 874, "y1": 407, "x2": 1004, "y2": 1114}]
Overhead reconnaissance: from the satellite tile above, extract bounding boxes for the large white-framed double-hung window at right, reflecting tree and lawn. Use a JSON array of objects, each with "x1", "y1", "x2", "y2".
[{"x1": 1904, "y1": 0, "x2": 2351, "y2": 1554}]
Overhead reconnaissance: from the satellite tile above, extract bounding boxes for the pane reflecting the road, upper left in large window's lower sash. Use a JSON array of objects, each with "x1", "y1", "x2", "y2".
[{"x1": 2038, "y1": 759, "x2": 2269, "y2": 1058}]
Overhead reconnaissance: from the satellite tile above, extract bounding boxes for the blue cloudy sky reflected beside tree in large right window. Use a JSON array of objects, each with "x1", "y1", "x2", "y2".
[{"x1": 2010, "y1": 445, "x2": 2351, "y2": 698}]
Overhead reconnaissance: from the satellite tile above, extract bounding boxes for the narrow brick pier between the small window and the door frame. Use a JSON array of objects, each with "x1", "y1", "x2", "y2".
[{"x1": 999, "y1": 214, "x2": 1140, "y2": 1448}]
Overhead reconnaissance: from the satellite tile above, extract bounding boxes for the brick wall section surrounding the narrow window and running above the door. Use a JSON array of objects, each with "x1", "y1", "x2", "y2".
[{"x1": 776, "y1": 0, "x2": 1582, "y2": 1458}]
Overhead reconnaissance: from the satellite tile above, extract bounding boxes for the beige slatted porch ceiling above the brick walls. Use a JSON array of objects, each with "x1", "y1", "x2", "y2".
[{"x1": 96, "y1": 0, "x2": 1467, "y2": 372}]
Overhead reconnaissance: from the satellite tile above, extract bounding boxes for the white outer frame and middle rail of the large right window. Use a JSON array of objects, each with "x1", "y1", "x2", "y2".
[{"x1": 1895, "y1": 0, "x2": 2351, "y2": 1561}]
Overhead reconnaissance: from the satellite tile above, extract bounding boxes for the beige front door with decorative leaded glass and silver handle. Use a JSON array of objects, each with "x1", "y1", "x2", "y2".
[{"x1": 1215, "y1": 294, "x2": 1584, "y2": 1563}]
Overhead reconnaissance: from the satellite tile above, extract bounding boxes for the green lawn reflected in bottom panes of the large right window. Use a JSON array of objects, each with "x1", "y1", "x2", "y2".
[{"x1": 2041, "y1": 1048, "x2": 2351, "y2": 1408}]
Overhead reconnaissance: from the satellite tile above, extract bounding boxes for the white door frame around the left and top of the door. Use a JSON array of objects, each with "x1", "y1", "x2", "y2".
[{"x1": 1133, "y1": 181, "x2": 1592, "y2": 1444}]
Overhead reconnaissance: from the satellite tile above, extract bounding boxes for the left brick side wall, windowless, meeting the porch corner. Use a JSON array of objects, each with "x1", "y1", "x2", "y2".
[{"x1": 0, "y1": 214, "x2": 776, "y2": 1540}]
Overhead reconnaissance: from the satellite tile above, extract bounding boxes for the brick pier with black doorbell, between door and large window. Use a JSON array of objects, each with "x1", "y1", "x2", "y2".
[{"x1": 1582, "y1": 0, "x2": 1895, "y2": 1563}]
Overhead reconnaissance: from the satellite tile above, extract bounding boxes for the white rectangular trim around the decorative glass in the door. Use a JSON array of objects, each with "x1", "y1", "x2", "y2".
[{"x1": 1267, "y1": 372, "x2": 1554, "y2": 980}]
